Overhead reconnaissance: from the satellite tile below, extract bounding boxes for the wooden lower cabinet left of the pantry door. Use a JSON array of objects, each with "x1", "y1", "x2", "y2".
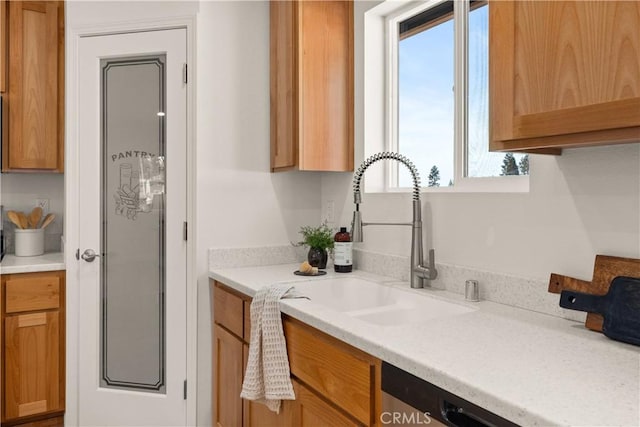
[{"x1": 0, "y1": 271, "x2": 65, "y2": 426}]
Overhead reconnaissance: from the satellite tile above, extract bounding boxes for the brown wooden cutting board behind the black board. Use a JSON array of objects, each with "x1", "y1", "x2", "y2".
[{"x1": 548, "y1": 255, "x2": 640, "y2": 332}]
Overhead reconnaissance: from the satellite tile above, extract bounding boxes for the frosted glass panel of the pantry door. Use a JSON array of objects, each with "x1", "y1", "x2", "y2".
[{"x1": 100, "y1": 55, "x2": 165, "y2": 393}]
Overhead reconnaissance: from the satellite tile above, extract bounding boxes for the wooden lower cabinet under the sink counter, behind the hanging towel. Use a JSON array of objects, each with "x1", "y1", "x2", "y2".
[{"x1": 211, "y1": 282, "x2": 381, "y2": 427}]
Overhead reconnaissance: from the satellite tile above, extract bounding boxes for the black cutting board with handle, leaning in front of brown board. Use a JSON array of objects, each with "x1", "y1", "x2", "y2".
[{"x1": 560, "y1": 276, "x2": 640, "y2": 345}]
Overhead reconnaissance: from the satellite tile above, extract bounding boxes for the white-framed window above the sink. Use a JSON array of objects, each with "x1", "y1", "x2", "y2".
[{"x1": 386, "y1": 0, "x2": 529, "y2": 191}]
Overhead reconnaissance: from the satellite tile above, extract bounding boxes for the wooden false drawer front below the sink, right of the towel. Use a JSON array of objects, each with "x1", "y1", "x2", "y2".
[{"x1": 283, "y1": 319, "x2": 375, "y2": 425}]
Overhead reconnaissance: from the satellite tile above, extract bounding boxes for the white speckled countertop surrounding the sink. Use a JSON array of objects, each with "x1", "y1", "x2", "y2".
[{"x1": 209, "y1": 264, "x2": 640, "y2": 426}]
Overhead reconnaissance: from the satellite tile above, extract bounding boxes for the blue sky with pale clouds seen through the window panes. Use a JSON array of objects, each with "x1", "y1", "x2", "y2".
[{"x1": 398, "y1": 7, "x2": 519, "y2": 186}]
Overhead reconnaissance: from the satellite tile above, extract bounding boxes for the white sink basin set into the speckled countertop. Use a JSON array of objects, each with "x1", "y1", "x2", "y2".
[{"x1": 295, "y1": 277, "x2": 475, "y2": 326}]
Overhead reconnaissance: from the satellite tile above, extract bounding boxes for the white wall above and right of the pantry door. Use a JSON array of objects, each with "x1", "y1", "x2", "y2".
[{"x1": 67, "y1": 1, "x2": 321, "y2": 426}]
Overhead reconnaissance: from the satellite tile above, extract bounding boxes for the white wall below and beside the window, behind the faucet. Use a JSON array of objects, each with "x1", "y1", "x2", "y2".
[{"x1": 322, "y1": 1, "x2": 640, "y2": 280}]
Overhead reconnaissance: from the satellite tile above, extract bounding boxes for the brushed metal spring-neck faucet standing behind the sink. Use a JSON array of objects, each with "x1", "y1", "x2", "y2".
[{"x1": 351, "y1": 151, "x2": 438, "y2": 288}]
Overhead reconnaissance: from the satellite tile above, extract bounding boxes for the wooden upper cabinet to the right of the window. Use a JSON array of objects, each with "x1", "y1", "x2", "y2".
[{"x1": 489, "y1": 1, "x2": 640, "y2": 153}]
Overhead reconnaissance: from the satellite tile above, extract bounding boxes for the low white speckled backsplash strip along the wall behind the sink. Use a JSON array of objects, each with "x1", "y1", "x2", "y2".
[{"x1": 209, "y1": 246, "x2": 586, "y2": 322}]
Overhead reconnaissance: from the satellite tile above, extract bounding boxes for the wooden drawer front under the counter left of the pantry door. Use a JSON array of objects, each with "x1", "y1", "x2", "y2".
[{"x1": 5, "y1": 274, "x2": 61, "y2": 313}]
